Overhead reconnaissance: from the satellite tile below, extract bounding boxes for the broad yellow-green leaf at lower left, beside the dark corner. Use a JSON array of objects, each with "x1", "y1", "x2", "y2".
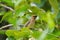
[{"x1": 5, "y1": 30, "x2": 22, "y2": 39}]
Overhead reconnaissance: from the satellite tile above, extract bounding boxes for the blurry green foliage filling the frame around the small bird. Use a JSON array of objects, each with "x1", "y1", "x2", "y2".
[{"x1": 0, "y1": 0, "x2": 60, "y2": 40}]
